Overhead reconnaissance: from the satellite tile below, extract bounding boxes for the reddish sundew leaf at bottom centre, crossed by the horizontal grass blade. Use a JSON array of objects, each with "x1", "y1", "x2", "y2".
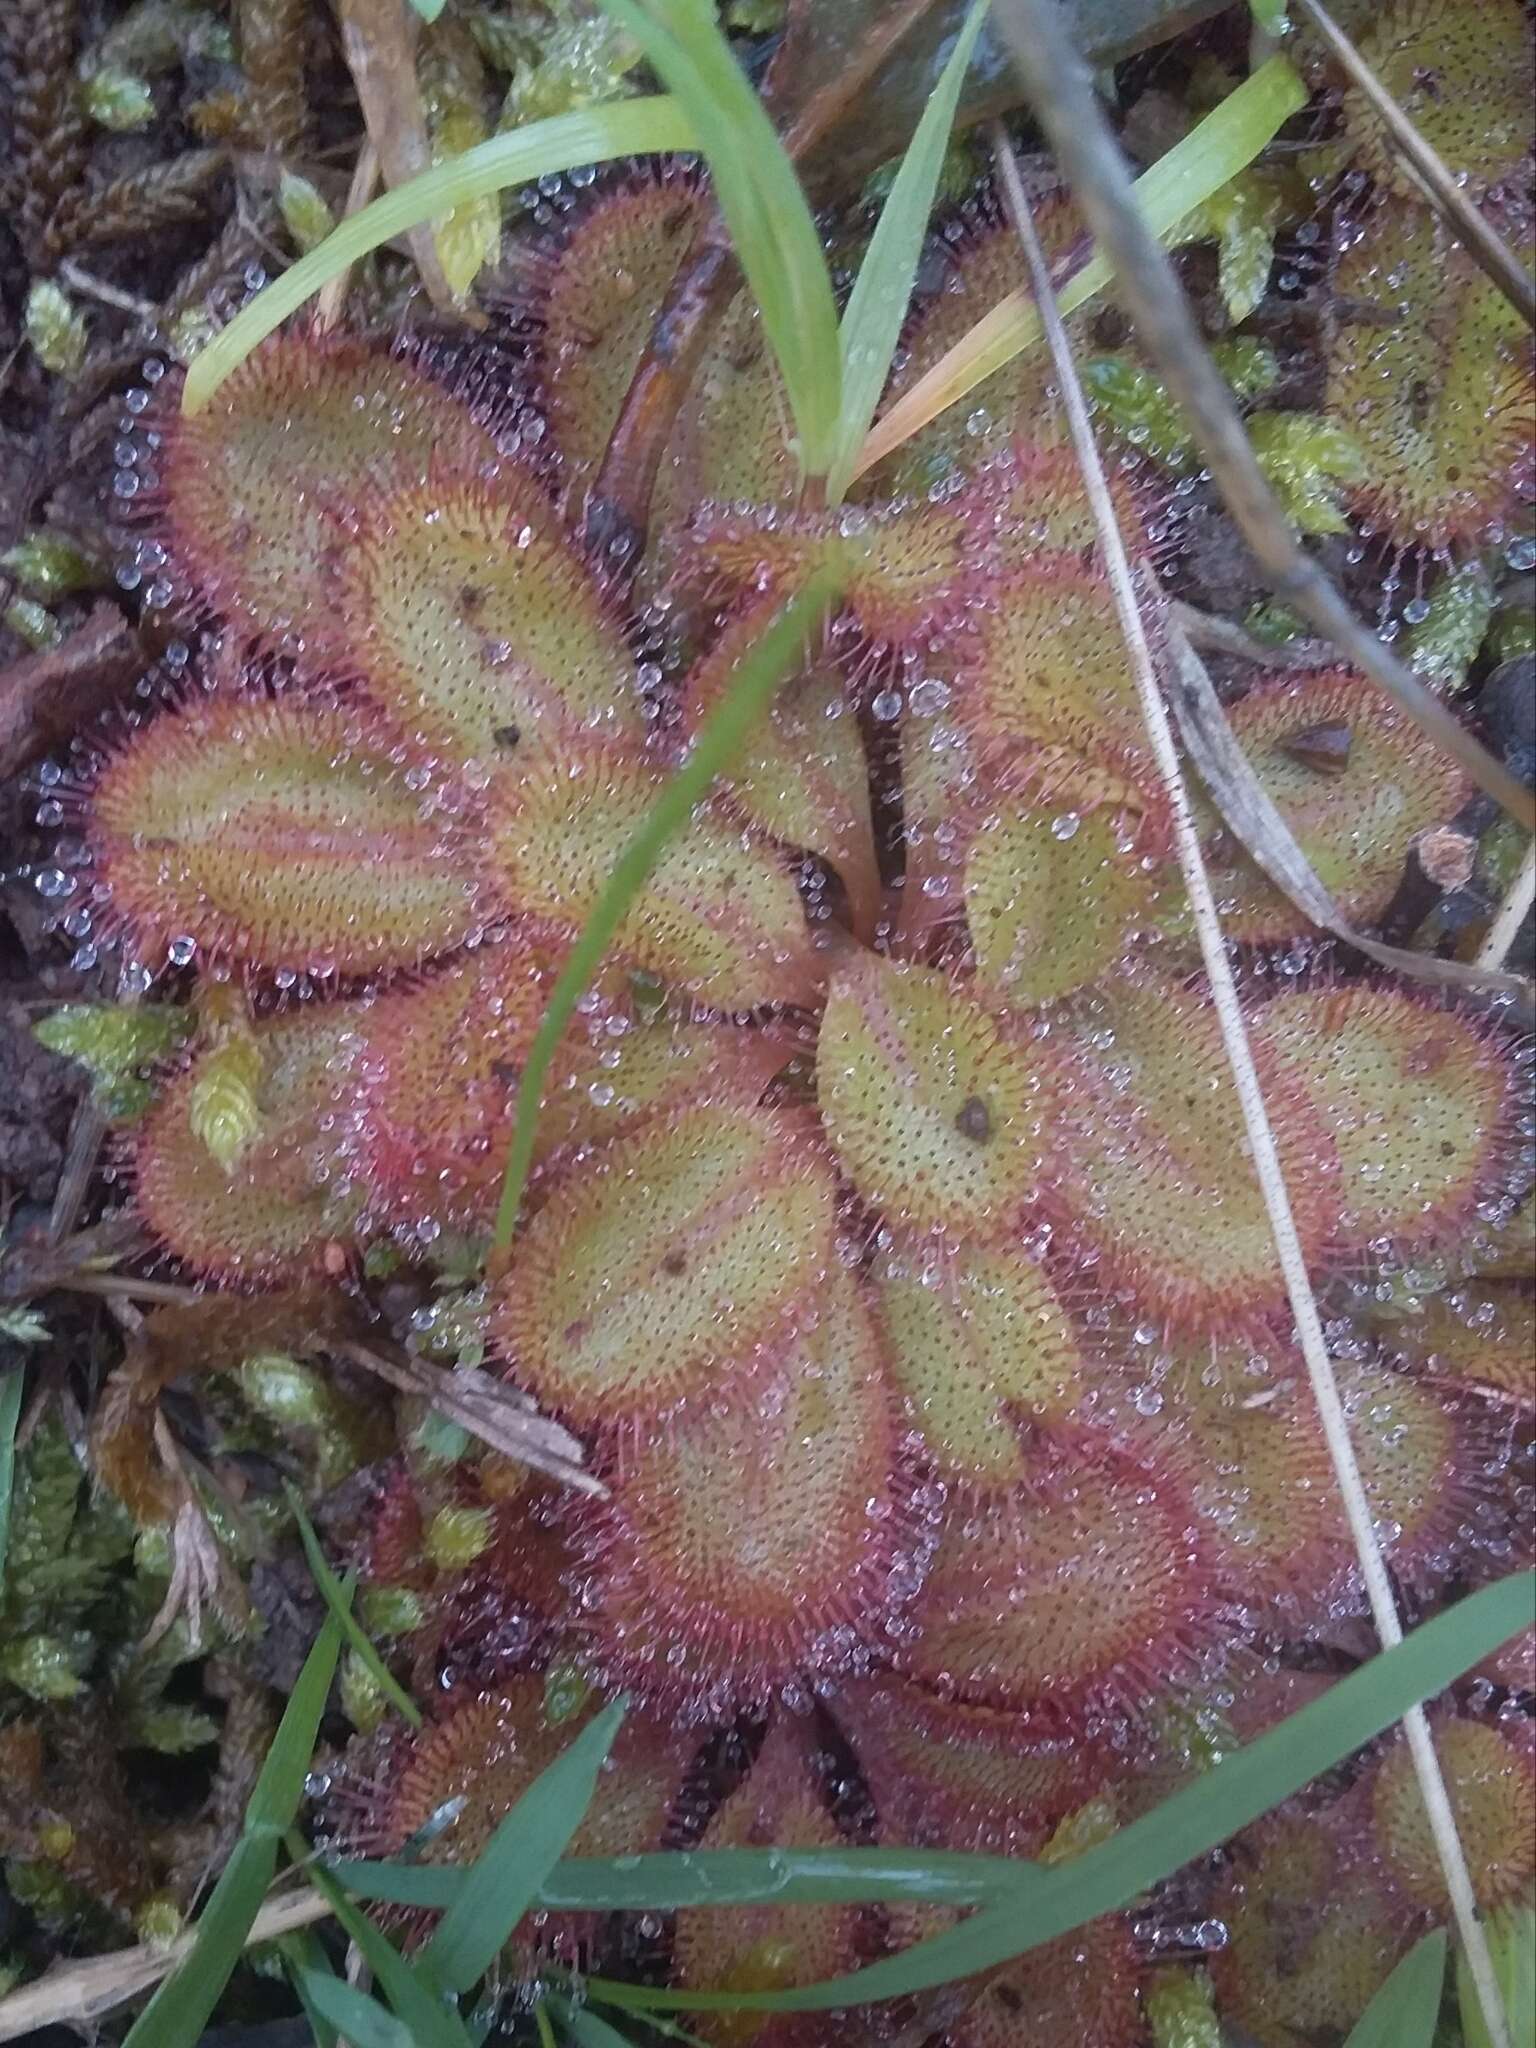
[{"x1": 672, "y1": 1714, "x2": 862, "y2": 2048}]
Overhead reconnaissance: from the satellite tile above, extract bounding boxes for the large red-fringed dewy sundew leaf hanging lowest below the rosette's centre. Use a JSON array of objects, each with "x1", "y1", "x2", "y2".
[{"x1": 584, "y1": 1266, "x2": 920, "y2": 1716}]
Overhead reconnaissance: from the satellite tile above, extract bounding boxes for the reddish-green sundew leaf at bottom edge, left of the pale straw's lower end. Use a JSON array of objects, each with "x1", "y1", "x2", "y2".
[{"x1": 1210, "y1": 1808, "x2": 1413, "y2": 2048}]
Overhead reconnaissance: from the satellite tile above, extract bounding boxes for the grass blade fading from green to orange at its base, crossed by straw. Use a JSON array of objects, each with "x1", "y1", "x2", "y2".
[{"x1": 852, "y1": 57, "x2": 1307, "y2": 477}]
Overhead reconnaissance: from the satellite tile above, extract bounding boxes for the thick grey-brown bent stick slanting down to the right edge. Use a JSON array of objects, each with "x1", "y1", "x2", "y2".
[{"x1": 991, "y1": 0, "x2": 1536, "y2": 831}]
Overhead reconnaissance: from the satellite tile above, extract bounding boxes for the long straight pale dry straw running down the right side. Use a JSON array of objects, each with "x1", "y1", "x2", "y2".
[{"x1": 995, "y1": 103, "x2": 1511, "y2": 2048}]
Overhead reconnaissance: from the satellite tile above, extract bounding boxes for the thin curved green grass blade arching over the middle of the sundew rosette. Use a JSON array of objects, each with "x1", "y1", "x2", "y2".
[{"x1": 492, "y1": 569, "x2": 842, "y2": 1255}]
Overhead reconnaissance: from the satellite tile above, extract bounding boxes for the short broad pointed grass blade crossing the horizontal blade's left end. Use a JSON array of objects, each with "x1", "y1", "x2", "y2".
[{"x1": 422, "y1": 1700, "x2": 625, "y2": 1991}]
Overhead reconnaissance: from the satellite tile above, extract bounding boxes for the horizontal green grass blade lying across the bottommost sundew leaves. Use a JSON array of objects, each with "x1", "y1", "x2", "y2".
[{"x1": 328, "y1": 1849, "x2": 1034, "y2": 1913}]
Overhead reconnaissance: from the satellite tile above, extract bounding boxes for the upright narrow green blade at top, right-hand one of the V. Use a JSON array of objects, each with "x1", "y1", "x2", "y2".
[{"x1": 827, "y1": 0, "x2": 987, "y2": 504}]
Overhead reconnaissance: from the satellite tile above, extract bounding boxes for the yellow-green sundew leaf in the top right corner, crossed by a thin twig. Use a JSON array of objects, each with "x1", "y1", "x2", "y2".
[{"x1": 1339, "y1": 0, "x2": 1536, "y2": 203}]
